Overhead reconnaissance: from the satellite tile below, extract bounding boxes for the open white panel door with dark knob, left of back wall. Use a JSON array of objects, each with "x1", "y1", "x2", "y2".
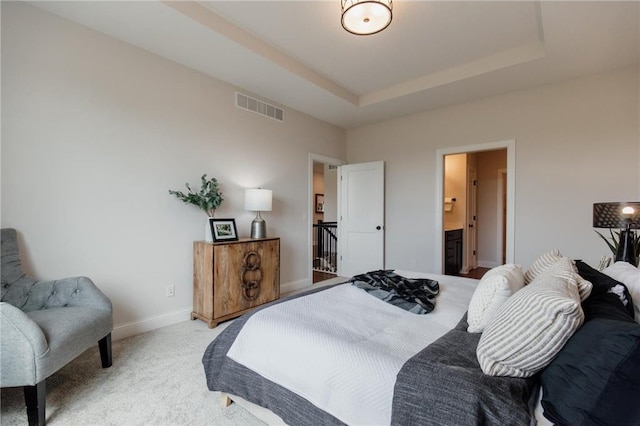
[{"x1": 338, "y1": 161, "x2": 384, "y2": 277}]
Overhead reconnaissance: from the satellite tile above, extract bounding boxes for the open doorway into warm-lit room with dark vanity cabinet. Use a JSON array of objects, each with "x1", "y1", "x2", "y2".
[{"x1": 437, "y1": 141, "x2": 515, "y2": 278}]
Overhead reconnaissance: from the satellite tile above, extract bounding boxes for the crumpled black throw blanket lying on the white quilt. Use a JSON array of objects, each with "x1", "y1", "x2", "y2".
[{"x1": 349, "y1": 269, "x2": 440, "y2": 314}]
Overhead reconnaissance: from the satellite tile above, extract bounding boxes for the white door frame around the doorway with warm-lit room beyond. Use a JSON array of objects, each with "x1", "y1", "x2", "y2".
[{"x1": 433, "y1": 139, "x2": 516, "y2": 274}]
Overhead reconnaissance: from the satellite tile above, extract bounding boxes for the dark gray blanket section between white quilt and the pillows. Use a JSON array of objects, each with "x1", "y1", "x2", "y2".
[{"x1": 391, "y1": 314, "x2": 537, "y2": 426}]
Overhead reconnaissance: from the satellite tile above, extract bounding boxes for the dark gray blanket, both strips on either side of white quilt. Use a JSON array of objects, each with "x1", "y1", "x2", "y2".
[{"x1": 202, "y1": 288, "x2": 536, "y2": 426}]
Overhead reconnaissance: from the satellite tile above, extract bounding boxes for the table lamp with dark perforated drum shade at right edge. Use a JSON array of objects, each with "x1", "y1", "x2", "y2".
[{"x1": 593, "y1": 201, "x2": 640, "y2": 266}]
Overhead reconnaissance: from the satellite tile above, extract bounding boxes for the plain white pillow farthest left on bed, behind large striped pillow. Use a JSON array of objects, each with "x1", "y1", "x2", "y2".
[{"x1": 467, "y1": 264, "x2": 524, "y2": 333}]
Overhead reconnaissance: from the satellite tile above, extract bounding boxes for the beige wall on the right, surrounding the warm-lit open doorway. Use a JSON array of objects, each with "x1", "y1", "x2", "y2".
[{"x1": 347, "y1": 67, "x2": 640, "y2": 271}]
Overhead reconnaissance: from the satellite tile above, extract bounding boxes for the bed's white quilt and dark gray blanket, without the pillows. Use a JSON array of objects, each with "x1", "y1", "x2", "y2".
[{"x1": 203, "y1": 271, "x2": 537, "y2": 425}]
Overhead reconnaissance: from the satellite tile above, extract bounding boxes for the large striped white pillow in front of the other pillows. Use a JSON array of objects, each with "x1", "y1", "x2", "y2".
[{"x1": 476, "y1": 268, "x2": 584, "y2": 377}]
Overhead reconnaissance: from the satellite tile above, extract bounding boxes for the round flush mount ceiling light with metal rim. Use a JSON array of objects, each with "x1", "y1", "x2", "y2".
[{"x1": 341, "y1": 0, "x2": 393, "y2": 35}]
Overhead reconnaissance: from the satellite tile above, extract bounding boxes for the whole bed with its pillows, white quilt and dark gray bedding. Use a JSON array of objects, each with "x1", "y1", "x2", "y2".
[{"x1": 202, "y1": 260, "x2": 640, "y2": 426}]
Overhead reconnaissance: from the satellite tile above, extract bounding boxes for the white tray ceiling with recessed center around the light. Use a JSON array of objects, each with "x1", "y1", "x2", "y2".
[{"x1": 30, "y1": 0, "x2": 640, "y2": 129}]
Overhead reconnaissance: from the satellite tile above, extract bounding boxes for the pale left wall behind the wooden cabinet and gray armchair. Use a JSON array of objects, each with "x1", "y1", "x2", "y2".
[{"x1": 2, "y1": 2, "x2": 346, "y2": 337}]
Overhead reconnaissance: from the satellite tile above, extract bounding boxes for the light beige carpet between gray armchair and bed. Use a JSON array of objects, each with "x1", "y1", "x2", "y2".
[{"x1": 0, "y1": 320, "x2": 264, "y2": 426}]
